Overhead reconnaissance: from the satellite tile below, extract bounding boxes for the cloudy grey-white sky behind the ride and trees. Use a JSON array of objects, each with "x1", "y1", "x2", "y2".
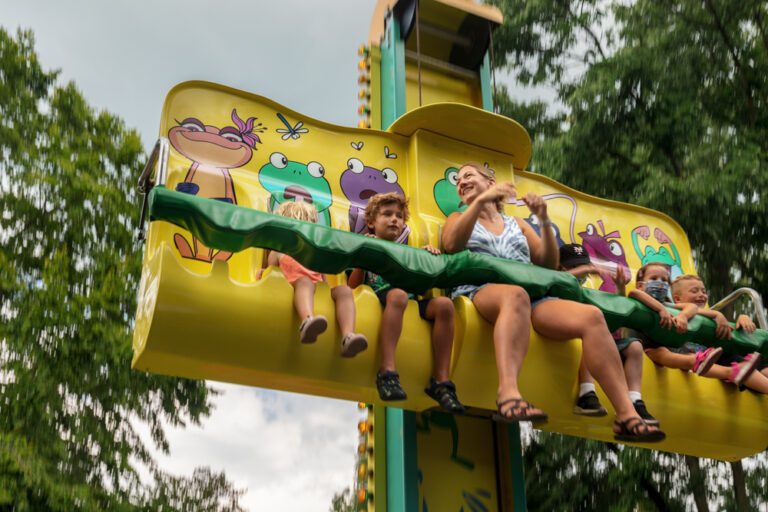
[{"x1": 0, "y1": 0, "x2": 544, "y2": 512}]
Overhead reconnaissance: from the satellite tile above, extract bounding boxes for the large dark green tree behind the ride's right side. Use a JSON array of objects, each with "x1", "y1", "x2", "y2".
[{"x1": 493, "y1": 0, "x2": 768, "y2": 510}]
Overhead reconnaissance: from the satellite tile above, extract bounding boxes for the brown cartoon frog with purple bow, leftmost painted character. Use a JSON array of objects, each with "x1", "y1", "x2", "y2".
[{"x1": 168, "y1": 109, "x2": 266, "y2": 262}]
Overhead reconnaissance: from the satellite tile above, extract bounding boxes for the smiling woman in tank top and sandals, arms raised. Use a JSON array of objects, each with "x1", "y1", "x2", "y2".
[{"x1": 442, "y1": 163, "x2": 665, "y2": 442}]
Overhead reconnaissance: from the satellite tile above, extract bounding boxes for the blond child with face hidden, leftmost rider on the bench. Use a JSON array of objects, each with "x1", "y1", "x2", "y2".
[{"x1": 267, "y1": 201, "x2": 368, "y2": 357}]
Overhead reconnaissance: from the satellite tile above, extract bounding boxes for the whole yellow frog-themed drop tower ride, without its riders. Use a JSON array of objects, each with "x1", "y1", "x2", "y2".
[{"x1": 133, "y1": 0, "x2": 768, "y2": 511}]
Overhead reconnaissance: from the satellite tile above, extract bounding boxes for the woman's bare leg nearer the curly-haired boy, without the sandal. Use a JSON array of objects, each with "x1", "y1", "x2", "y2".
[{"x1": 472, "y1": 284, "x2": 540, "y2": 414}]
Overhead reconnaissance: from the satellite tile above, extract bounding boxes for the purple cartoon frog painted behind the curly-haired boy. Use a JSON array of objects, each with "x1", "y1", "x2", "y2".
[{"x1": 339, "y1": 158, "x2": 411, "y2": 243}]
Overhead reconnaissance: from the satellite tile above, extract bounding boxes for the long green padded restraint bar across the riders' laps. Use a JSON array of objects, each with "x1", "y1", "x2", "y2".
[{"x1": 149, "y1": 187, "x2": 768, "y2": 357}]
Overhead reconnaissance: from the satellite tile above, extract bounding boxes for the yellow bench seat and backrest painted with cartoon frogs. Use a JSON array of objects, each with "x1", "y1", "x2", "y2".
[{"x1": 133, "y1": 82, "x2": 768, "y2": 460}]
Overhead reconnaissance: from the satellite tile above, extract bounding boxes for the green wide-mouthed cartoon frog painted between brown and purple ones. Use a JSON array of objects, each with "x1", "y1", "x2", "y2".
[{"x1": 259, "y1": 152, "x2": 333, "y2": 226}]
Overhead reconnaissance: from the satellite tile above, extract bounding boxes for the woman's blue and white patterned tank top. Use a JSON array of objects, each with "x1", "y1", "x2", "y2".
[{"x1": 451, "y1": 215, "x2": 531, "y2": 299}]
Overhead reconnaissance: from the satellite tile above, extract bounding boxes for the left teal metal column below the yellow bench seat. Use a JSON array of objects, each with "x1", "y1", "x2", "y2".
[{"x1": 386, "y1": 407, "x2": 419, "y2": 512}]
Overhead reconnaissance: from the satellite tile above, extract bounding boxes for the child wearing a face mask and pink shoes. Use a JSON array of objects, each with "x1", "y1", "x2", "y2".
[{"x1": 629, "y1": 263, "x2": 760, "y2": 386}]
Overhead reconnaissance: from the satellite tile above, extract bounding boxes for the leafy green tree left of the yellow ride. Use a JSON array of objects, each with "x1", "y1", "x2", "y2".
[{"x1": 0, "y1": 29, "x2": 243, "y2": 510}]
